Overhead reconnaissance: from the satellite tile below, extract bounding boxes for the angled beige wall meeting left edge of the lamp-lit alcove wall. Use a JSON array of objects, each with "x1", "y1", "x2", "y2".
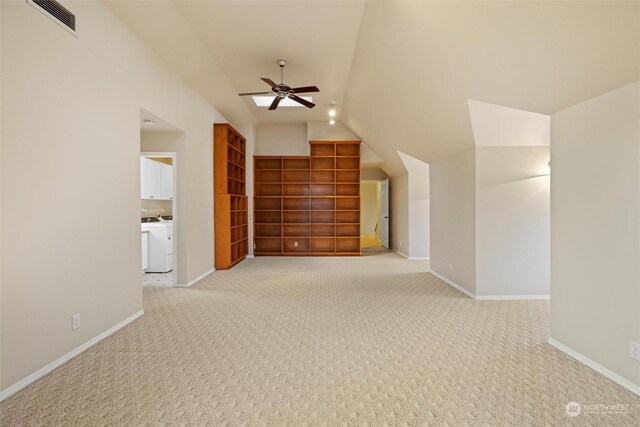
[{"x1": 429, "y1": 147, "x2": 476, "y2": 294}]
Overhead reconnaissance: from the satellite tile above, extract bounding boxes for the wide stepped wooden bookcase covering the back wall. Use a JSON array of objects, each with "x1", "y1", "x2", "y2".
[{"x1": 254, "y1": 141, "x2": 360, "y2": 256}]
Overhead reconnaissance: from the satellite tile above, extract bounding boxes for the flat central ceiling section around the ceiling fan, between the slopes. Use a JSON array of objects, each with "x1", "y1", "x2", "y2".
[{"x1": 178, "y1": 1, "x2": 364, "y2": 124}]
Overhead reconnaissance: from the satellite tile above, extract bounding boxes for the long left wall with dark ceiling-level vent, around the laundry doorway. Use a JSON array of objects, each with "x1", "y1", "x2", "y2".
[{"x1": 0, "y1": 2, "x2": 242, "y2": 389}]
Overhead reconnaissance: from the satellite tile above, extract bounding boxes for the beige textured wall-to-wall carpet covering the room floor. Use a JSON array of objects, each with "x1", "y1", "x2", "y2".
[{"x1": 0, "y1": 254, "x2": 640, "y2": 426}]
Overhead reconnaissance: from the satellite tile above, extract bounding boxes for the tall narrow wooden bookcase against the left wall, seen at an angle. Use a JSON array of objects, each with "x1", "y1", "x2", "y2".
[{"x1": 213, "y1": 124, "x2": 249, "y2": 270}]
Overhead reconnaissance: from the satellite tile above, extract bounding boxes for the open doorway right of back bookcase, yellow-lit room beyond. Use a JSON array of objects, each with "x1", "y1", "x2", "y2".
[{"x1": 360, "y1": 179, "x2": 389, "y2": 252}]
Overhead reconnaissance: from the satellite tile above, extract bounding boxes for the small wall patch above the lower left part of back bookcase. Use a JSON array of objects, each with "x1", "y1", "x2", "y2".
[{"x1": 256, "y1": 124, "x2": 311, "y2": 156}]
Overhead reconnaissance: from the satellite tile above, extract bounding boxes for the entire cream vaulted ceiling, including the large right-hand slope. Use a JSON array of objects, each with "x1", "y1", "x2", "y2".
[{"x1": 102, "y1": 0, "x2": 640, "y2": 175}]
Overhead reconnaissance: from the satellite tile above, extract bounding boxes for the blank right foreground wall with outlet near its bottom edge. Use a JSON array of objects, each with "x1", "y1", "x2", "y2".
[{"x1": 551, "y1": 83, "x2": 640, "y2": 390}]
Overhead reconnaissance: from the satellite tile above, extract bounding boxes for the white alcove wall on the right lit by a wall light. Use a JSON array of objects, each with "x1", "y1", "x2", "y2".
[{"x1": 476, "y1": 146, "x2": 550, "y2": 296}]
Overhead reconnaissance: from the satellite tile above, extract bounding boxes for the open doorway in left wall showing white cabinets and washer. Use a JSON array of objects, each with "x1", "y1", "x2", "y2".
[{"x1": 140, "y1": 110, "x2": 183, "y2": 286}]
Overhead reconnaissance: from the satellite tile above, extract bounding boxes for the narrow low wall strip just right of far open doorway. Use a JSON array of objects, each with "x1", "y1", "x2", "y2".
[{"x1": 389, "y1": 172, "x2": 409, "y2": 257}]
